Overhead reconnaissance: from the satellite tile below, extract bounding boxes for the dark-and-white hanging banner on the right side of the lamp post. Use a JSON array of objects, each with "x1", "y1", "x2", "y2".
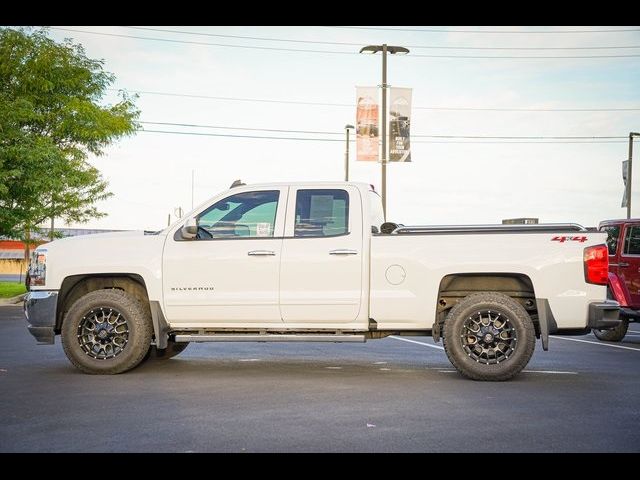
[{"x1": 389, "y1": 87, "x2": 412, "y2": 162}]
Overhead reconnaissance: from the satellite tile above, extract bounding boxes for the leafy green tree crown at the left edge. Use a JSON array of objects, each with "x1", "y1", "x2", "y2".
[{"x1": 0, "y1": 28, "x2": 140, "y2": 238}]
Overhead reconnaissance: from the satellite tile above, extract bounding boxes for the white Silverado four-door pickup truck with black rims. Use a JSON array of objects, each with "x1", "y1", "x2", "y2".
[{"x1": 24, "y1": 182, "x2": 619, "y2": 380}]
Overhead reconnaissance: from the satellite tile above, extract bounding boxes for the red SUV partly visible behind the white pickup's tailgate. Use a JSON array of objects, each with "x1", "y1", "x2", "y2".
[{"x1": 593, "y1": 218, "x2": 640, "y2": 342}]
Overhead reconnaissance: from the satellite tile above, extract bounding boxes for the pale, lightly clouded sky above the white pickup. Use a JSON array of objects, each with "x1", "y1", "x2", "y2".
[{"x1": 38, "y1": 26, "x2": 640, "y2": 230}]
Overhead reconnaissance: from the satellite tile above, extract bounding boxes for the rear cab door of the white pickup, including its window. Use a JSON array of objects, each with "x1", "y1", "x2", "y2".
[{"x1": 280, "y1": 186, "x2": 364, "y2": 328}]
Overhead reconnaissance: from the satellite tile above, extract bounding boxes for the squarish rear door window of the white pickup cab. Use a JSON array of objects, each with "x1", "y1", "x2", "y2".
[{"x1": 294, "y1": 189, "x2": 349, "y2": 237}]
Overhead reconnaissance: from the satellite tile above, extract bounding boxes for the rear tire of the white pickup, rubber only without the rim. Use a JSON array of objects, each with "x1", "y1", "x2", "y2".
[{"x1": 443, "y1": 292, "x2": 536, "y2": 381}]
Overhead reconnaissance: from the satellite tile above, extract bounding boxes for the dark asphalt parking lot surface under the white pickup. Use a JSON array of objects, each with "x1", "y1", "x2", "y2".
[{"x1": 0, "y1": 306, "x2": 640, "y2": 452}]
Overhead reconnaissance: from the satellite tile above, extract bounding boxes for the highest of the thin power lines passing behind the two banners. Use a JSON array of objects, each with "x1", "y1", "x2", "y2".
[{"x1": 115, "y1": 88, "x2": 640, "y2": 112}]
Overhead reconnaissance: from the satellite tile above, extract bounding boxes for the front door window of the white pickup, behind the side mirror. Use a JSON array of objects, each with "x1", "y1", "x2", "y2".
[{"x1": 198, "y1": 190, "x2": 280, "y2": 240}]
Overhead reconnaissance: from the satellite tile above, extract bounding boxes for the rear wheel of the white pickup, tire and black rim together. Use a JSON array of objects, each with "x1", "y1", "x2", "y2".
[{"x1": 443, "y1": 292, "x2": 536, "y2": 381}]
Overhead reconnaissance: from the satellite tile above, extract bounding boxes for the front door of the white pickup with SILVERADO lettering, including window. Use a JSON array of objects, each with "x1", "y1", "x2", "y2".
[{"x1": 163, "y1": 187, "x2": 288, "y2": 328}]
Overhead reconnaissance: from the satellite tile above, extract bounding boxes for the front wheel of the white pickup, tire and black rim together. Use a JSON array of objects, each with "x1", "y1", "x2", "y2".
[{"x1": 62, "y1": 289, "x2": 152, "y2": 375}]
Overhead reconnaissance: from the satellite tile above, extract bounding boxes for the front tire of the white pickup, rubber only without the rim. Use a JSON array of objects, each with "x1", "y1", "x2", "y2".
[{"x1": 61, "y1": 290, "x2": 151, "y2": 374}]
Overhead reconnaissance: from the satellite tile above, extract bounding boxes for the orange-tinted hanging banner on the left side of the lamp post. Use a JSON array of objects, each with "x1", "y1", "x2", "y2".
[{"x1": 356, "y1": 87, "x2": 380, "y2": 162}]
